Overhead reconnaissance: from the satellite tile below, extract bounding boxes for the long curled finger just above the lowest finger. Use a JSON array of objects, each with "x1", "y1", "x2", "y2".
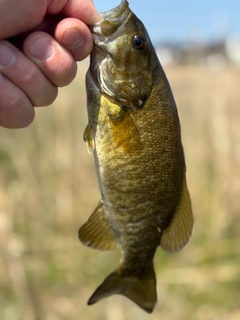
[{"x1": 0, "y1": 41, "x2": 57, "y2": 106}]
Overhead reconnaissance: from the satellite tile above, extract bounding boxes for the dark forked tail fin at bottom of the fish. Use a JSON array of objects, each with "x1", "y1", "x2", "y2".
[{"x1": 88, "y1": 266, "x2": 157, "y2": 313}]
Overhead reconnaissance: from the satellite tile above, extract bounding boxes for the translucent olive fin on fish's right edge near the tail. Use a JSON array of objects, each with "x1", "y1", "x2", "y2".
[{"x1": 160, "y1": 177, "x2": 193, "y2": 252}]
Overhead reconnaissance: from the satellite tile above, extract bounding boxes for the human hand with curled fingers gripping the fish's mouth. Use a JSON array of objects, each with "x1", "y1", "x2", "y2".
[{"x1": 0, "y1": 0, "x2": 100, "y2": 128}]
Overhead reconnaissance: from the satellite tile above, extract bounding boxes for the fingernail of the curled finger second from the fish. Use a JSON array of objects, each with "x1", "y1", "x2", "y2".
[{"x1": 30, "y1": 38, "x2": 54, "y2": 61}]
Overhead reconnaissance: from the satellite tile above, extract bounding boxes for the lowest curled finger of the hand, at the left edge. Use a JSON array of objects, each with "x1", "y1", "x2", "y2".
[{"x1": 0, "y1": 73, "x2": 35, "y2": 128}]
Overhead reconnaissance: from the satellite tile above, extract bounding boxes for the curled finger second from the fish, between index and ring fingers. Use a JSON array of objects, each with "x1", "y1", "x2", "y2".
[{"x1": 23, "y1": 31, "x2": 77, "y2": 87}]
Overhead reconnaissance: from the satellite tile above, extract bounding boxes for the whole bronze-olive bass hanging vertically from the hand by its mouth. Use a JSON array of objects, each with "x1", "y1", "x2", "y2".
[{"x1": 78, "y1": 0, "x2": 194, "y2": 313}]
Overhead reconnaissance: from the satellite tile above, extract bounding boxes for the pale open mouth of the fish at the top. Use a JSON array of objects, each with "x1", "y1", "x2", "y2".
[{"x1": 89, "y1": 0, "x2": 131, "y2": 37}]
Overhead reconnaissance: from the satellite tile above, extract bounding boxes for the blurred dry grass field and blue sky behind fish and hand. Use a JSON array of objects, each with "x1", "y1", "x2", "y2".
[{"x1": 0, "y1": 0, "x2": 240, "y2": 320}]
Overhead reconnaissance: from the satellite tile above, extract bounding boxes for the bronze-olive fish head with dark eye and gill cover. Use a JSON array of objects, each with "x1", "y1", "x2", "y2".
[{"x1": 90, "y1": 0, "x2": 159, "y2": 109}]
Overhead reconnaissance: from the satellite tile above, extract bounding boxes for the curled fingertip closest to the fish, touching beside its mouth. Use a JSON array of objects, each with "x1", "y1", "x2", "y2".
[{"x1": 55, "y1": 18, "x2": 93, "y2": 61}]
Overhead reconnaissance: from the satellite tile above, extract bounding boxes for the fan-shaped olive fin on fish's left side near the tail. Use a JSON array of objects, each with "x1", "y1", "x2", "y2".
[{"x1": 78, "y1": 201, "x2": 118, "y2": 250}]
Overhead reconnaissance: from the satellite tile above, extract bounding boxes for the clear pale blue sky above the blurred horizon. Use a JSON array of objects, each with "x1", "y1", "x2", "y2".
[{"x1": 94, "y1": 0, "x2": 240, "y2": 43}]
